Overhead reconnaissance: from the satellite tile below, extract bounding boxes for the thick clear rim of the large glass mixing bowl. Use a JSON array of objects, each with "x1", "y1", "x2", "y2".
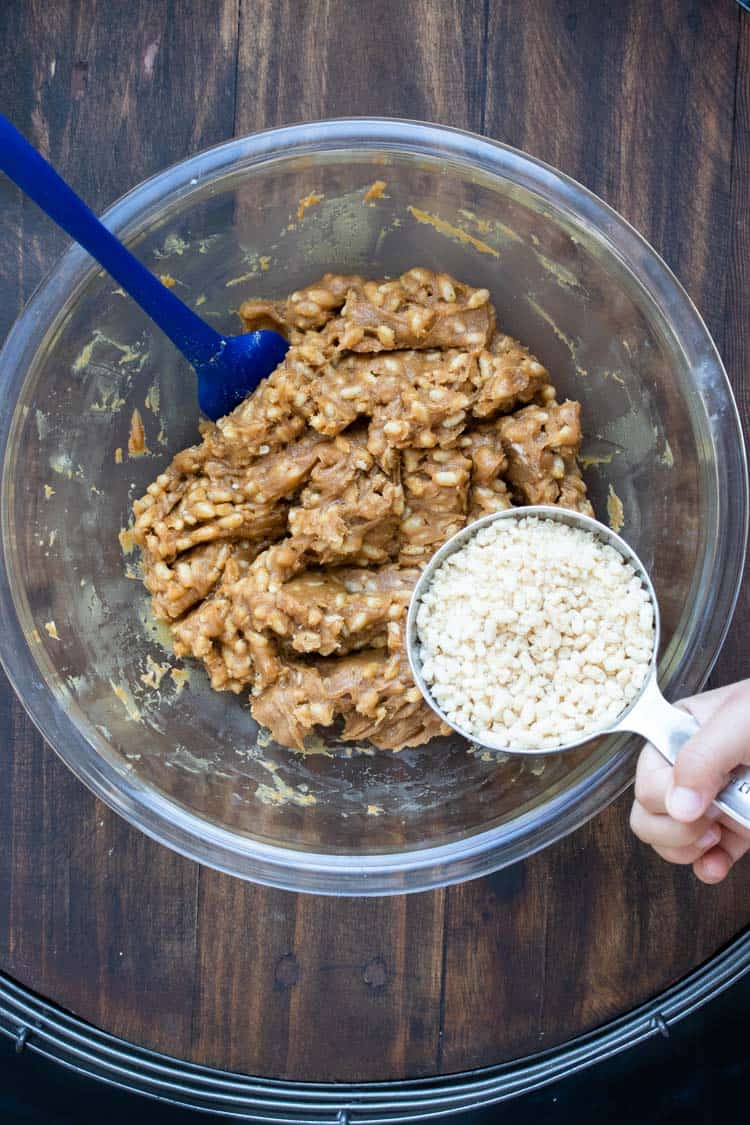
[{"x1": 0, "y1": 116, "x2": 749, "y2": 896}]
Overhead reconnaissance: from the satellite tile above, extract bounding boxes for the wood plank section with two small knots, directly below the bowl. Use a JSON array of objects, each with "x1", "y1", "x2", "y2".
[{"x1": 191, "y1": 875, "x2": 444, "y2": 1081}]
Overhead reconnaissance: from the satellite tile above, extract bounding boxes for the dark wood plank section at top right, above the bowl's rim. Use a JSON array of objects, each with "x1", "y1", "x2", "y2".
[{"x1": 485, "y1": 0, "x2": 740, "y2": 344}]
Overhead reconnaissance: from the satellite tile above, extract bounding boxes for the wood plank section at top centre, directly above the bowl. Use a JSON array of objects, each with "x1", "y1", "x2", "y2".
[{"x1": 236, "y1": 0, "x2": 484, "y2": 133}]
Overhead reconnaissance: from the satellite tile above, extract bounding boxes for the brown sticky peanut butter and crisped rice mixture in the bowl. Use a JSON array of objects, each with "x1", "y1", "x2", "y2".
[{"x1": 133, "y1": 269, "x2": 591, "y2": 749}]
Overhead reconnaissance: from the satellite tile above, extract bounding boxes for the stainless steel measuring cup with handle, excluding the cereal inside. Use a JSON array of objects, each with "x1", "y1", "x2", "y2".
[{"x1": 406, "y1": 505, "x2": 750, "y2": 828}]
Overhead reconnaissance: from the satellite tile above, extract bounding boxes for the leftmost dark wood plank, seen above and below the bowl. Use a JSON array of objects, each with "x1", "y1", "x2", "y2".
[{"x1": 0, "y1": 0, "x2": 237, "y2": 1053}]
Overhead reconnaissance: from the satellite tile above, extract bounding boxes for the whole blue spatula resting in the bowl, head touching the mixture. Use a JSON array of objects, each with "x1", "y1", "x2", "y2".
[{"x1": 0, "y1": 114, "x2": 289, "y2": 421}]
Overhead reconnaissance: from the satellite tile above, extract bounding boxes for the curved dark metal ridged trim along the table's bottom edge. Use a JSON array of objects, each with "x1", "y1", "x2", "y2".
[{"x1": 0, "y1": 929, "x2": 750, "y2": 1125}]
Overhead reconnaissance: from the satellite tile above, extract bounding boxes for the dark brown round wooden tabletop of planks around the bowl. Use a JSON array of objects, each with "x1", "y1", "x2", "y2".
[{"x1": 0, "y1": 0, "x2": 750, "y2": 1080}]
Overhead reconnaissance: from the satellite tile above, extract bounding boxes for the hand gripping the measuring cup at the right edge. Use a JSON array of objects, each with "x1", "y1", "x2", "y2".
[{"x1": 630, "y1": 680, "x2": 750, "y2": 883}]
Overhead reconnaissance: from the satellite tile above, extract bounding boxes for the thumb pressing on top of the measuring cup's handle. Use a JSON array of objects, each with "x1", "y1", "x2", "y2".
[{"x1": 667, "y1": 680, "x2": 750, "y2": 822}]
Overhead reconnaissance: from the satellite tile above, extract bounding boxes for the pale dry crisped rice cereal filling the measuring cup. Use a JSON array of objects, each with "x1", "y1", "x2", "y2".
[{"x1": 417, "y1": 516, "x2": 654, "y2": 748}]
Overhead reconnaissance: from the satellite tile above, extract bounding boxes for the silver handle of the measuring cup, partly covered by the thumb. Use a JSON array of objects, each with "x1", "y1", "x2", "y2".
[{"x1": 626, "y1": 681, "x2": 750, "y2": 829}]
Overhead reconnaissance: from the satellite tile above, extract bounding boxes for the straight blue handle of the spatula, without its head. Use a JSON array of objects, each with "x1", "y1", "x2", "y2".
[{"x1": 0, "y1": 114, "x2": 224, "y2": 367}]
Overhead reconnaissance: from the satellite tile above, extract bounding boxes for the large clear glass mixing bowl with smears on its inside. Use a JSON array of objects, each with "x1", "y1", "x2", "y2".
[{"x1": 0, "y1": 119, "x2": 748, "y2": 894}]
